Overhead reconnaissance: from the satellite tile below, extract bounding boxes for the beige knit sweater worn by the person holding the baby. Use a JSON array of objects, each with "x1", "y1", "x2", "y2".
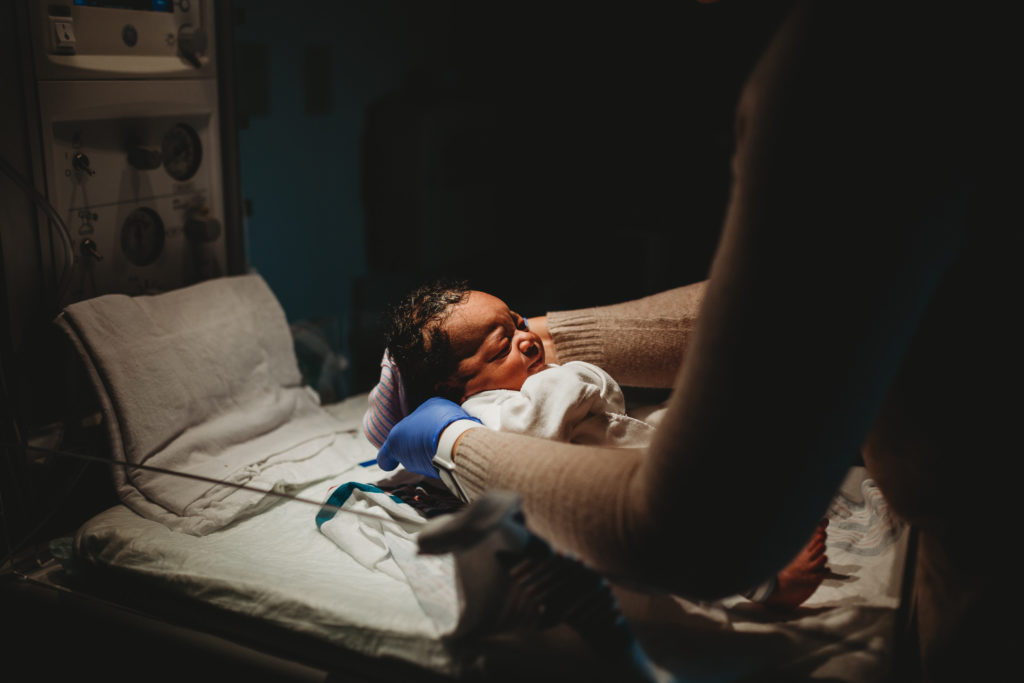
[{"x1": 455, "y1": 2, "x2": 1024, "y2": 681}]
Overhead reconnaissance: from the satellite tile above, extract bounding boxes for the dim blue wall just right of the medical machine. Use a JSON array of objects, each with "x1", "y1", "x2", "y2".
[{"x1": 234, "y1": 0, "x2": 445, "y2": 389}]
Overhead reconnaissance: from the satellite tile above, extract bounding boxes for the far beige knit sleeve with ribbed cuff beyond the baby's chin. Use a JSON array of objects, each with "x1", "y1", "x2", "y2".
[{"x1": 547, "y1": 281, "x2": 708, "y2": 388}]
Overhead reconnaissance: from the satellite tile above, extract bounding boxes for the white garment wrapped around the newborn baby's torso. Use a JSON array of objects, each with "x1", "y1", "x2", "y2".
[{"x1": 462, "y1": 360, "x2": 654, "y2": 447}]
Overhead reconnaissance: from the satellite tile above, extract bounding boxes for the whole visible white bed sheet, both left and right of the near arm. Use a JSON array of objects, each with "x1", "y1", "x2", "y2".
[{"x1": 76, "y1": 394, "x2": 906, "y2": 683}]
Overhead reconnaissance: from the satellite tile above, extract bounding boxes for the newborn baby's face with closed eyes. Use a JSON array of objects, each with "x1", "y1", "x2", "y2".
[{"x1": 446, "y1": 290, "x2": 545, "y2": 400}]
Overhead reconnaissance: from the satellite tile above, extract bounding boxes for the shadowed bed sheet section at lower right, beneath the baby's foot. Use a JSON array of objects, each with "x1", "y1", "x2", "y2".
[{"x1": 616, "y1": 467, "x2": 908, "y2": 683}]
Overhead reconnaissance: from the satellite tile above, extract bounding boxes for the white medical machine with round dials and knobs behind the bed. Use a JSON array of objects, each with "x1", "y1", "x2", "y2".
[{"x1": 28, "y1": 0, "x2": 241, "y2": 303}]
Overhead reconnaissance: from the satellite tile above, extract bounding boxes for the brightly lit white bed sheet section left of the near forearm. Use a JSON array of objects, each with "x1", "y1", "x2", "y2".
[{"x1": 76, "y1": 395, "x2": 461, "y2": 676}]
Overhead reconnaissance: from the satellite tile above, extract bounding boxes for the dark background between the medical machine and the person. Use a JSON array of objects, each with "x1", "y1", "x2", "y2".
[{"x1": 234, "y1": 0, "x2": 788, "y2": 397}]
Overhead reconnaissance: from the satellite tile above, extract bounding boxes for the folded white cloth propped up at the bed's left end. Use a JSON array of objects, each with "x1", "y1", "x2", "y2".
[{"x1": 57, "y1": 274, "x2": 360, "y2": 536}]
